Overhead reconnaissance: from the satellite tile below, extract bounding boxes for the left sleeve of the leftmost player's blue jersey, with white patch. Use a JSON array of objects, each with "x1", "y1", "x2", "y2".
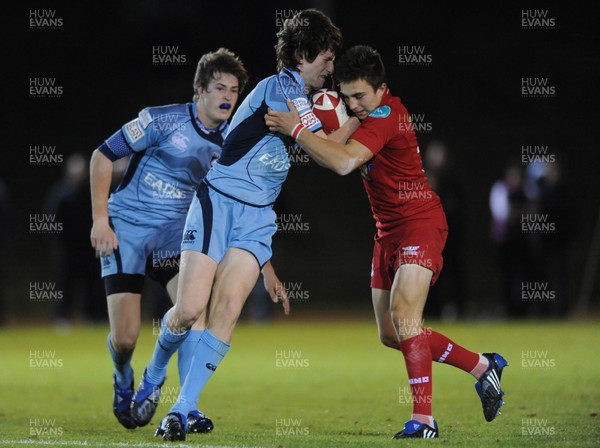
[{"x1": 98, "y1": 108, "x2": 160, "y2": 162}]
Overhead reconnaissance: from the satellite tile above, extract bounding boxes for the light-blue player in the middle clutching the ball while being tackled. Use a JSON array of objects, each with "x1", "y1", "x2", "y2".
[{"x1": 132, "y1": 9, "x2": 358, "y2": 440}]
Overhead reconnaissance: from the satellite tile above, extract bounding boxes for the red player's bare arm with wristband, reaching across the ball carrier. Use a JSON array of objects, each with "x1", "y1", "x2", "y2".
[{"x1": 265, "y1": 100, "x2": 373, "y2": 176}]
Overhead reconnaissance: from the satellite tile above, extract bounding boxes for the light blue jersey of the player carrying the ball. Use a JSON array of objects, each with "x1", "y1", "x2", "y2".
[{"x1": 205, "y1": 69, "x2": 321, "y2": 207}]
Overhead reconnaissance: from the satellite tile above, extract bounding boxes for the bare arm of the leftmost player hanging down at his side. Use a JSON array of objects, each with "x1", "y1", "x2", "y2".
[{"x1": 90, "y1": 149, "x2": 119, "y2": 257}]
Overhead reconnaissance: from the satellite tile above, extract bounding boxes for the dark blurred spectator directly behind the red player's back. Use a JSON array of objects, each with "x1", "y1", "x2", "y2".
[{"x1": 423, "y1": 141, "x2": 468, "y2": 319}]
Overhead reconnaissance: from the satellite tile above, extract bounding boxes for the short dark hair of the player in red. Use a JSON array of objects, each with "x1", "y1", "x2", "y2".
[{"x1": 335, "y1": 45, "x2": 385, "y2": 90}]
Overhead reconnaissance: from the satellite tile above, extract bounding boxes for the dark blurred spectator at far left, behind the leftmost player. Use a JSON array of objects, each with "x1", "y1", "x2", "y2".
[{"x1": 45, "y1": 154, "x2": 106, "y2": 325}]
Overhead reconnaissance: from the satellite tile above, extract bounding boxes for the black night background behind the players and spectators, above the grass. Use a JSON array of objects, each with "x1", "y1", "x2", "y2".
[{"x1": 0, "y1": 0, "x2": 600, "y2": 322}]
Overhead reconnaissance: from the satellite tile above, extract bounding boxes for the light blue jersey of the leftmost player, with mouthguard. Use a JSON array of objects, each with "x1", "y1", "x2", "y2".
[{"x1": 99, "y1": 103, "x2": 227, "y2": 220}]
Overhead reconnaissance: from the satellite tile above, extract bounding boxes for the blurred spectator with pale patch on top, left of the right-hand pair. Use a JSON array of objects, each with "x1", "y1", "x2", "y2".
[{"x1": 490, "y1": 161, "x2": 534, "y2": 317}]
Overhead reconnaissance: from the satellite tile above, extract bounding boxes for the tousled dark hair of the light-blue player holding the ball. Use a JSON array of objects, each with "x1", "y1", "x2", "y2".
[{"x1": 275, "y1": 9, "x2": 342, "y2": 71}]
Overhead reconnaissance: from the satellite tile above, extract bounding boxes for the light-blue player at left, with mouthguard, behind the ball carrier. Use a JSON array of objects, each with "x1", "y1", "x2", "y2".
[{"x1": 90, "y1": 48, "x2": 282, "y2": 432}]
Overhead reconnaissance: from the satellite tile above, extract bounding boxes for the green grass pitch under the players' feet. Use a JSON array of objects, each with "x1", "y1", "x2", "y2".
[{"x1": 0, "y1": 321, "x2": 600, "y2": 448}]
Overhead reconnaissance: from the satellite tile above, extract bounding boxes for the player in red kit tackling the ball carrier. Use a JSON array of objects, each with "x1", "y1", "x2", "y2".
[{"x1": 265, "y1": 46, "x2": 508, "y2": 438}]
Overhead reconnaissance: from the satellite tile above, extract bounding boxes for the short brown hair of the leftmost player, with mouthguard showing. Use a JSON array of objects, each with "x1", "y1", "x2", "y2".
[{"x1": 194, "y1": 48, "x2": 248, "y2": 101}]
